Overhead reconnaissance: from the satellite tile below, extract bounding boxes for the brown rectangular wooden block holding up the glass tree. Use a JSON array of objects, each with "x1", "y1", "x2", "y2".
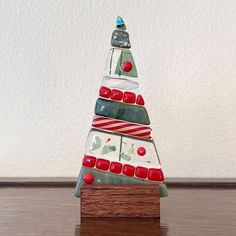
[{"x1": 81, "y1": 184, "x2": 160, "y2": 219}]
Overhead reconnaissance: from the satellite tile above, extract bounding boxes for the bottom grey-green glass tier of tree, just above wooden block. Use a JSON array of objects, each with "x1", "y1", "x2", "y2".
[{"x1": 75, "y1": 166, "x2": 168, "y2": 197}]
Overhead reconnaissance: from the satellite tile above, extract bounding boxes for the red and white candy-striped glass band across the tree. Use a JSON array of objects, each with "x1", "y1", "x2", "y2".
[{"x1": 92, "y1": 116, "x2": 151, "y2": 140}]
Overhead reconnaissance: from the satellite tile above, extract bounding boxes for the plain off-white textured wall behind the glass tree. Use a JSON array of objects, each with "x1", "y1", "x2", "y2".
[{"x1": 0, "y1": 0, "x2": 236, "y2": 177}]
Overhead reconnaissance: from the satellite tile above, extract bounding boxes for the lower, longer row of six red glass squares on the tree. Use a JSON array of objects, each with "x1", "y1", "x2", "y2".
[{"x1": 83, "y1": 155, "x2": 164, "y2": 181}]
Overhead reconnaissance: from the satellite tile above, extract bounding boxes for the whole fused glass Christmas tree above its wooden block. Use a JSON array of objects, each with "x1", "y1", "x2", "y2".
[{"x1": 75, "y1": 17, "x2": 168, "y2": 197}]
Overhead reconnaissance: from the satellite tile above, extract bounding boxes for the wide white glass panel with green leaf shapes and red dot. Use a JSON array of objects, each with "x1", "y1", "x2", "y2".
[{"x1": 85, "y1": 130, "x2": 161, "y2": 168}]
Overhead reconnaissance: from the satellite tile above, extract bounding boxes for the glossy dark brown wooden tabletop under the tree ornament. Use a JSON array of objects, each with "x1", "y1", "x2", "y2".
[{"x1": 0, "y1": 186, "x2": 236, "y2": 236}]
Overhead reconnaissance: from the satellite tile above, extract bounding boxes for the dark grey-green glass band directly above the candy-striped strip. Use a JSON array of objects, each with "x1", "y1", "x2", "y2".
[{"x1": 95, "y1": 98, "x2": 150, "y2": 125}]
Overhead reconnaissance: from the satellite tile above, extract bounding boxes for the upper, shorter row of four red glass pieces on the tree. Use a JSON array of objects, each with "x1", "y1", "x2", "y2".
[{"x1": 99, "y1": 86, "x2": 144, "y2": 106}]
